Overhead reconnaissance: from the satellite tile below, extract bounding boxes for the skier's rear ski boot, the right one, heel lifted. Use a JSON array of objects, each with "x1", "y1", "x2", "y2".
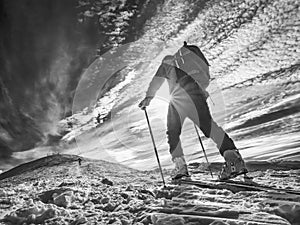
[{"x1": 219, "y1": 149, "x2": 248, "y2": 180}]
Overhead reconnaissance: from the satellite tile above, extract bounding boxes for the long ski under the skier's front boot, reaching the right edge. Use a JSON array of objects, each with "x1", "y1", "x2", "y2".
[{"x1": 173, "y1": 179, "x2": 300, "y2": 195}]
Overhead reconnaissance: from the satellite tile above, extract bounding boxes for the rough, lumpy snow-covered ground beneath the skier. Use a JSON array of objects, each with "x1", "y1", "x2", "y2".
[{"x1": 0, "y1": 155, "x2": 300, "y2": 225}]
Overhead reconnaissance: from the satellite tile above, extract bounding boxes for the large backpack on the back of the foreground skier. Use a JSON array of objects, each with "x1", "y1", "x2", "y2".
[{"x1": 174, "y1": 42, "x2": 210, "y2": 90}]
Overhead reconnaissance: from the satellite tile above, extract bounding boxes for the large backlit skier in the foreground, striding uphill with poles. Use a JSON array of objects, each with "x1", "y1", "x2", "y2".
[{"x1": 138, "y1": 42, "x2": 248, "y2": 180}]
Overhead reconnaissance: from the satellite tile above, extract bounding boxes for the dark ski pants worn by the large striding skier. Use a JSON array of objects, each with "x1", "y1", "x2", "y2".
[{"x1": 167, "y1": 77, "x2": 236, "y2": 159}]
